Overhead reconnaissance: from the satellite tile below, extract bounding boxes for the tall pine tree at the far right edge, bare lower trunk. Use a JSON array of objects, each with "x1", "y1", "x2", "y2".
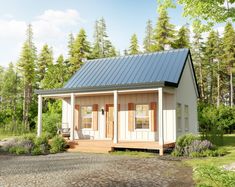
[{"x1": 223, "y1": 22, "x2": 235, "y2": 106}]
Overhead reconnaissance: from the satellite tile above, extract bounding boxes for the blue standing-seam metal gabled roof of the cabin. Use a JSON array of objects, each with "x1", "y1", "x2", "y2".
[{"x1": 36, "y1": 49, "x2": 195, "y2": 94}]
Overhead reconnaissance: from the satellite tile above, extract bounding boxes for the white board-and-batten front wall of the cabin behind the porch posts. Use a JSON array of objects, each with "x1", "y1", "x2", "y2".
[{"x1": 62, "y1": 93, "x2": 158, "y2": 141}]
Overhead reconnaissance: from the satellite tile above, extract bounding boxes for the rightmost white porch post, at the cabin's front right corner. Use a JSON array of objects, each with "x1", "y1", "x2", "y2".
[{"x1": 158, "y1": 88, "x2": 164, "y2": 155}]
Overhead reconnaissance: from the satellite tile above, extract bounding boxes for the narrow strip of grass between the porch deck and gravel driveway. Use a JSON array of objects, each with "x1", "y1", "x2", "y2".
[{"x1": 110, "y1": 151, "x2": 156, "y2": 158}]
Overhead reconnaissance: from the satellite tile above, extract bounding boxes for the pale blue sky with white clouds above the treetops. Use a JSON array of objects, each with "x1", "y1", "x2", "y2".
[{"x1": 0, "y1": 0, "x2": 202, "y2": 67}]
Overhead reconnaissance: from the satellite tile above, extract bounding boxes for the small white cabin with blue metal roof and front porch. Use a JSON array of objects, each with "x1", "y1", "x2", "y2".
[{"x1": 36, "y1": 49, "x2": 199, "y2": 155}]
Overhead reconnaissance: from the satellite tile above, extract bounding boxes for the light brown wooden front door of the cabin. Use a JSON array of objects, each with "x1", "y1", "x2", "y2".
[{"x1": 106, "y1": 105, "x2": 114, "y2": 139}]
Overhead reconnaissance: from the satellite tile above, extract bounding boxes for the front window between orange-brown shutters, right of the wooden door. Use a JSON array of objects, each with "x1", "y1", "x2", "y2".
[{"x1": 135, "y1": 105, "x2": 149, "y2": 129}]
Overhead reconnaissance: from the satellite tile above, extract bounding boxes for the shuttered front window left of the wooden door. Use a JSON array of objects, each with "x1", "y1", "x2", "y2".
[{"x1": 81, "y1": 106, "x2": 92, "y2": 129}]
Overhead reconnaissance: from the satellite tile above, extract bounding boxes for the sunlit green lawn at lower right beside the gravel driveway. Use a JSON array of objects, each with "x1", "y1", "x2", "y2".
[{"x1": 184, "y1": 134, "x2": 235, "y2": 187}]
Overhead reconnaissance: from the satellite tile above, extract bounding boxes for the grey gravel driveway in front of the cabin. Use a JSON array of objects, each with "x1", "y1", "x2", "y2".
[{"x1": 0, "y1": 153, "x2": 193, "y2": 187}]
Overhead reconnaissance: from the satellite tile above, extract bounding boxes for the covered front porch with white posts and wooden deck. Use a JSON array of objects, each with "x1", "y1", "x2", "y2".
[{"x1": 37, "y1": 87, "x2": 175, "y2": 155}]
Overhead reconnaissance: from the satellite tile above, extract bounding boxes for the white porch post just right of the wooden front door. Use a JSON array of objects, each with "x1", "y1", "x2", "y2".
[{"x1": 113, "y1": 90, "x2": 118, "y2": 144}]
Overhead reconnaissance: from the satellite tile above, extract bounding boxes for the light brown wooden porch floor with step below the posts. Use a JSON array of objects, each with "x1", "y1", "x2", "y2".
[{"x1": 68, "y1": 140, "x2": 175, "y2": 153}]
